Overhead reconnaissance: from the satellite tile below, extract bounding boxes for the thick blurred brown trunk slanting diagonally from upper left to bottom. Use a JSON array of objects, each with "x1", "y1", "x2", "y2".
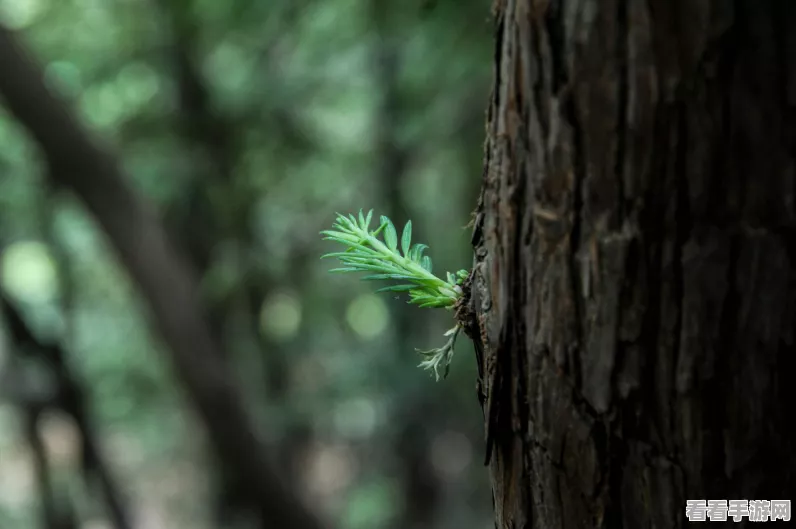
[{"x1": 0, "y1": 23, "x2": 321, "y2": 529}]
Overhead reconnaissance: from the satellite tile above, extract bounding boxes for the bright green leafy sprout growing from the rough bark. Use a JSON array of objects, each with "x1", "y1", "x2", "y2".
[{"x1": 321, "y1": 210, "x2": 469, "y2": 380}]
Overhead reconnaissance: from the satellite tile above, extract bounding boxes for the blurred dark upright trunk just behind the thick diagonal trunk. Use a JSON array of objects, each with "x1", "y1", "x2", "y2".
[{"x1": 157, "y1": 2, "x2": 318, "y2": 527}]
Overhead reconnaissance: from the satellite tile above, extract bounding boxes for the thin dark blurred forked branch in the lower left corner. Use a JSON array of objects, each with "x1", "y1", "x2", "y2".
[{"x1": 0, "y1": 292, "x2": 126, "y2": 529}]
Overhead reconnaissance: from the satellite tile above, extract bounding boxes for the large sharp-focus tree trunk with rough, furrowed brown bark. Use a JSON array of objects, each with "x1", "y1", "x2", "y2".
[{"x1": 472, "y1": 0, "x2": 796, "y2": 529}]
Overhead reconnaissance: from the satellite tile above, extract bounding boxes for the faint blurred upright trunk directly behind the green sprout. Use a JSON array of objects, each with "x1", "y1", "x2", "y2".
[{"x1": 370, "y1": 4, "x2": 442, "y2": 529}]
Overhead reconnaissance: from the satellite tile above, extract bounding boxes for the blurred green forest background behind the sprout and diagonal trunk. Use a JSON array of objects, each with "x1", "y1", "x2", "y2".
[{"x1": 0, "y1": 0, "x2": 492, "y2": 529}]
